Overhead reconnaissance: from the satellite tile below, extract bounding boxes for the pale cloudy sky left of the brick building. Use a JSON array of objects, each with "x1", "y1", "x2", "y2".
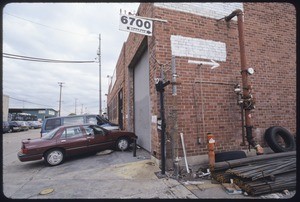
[{"x1": 2, "y1": 3, "x2": 139, "y2": 115}]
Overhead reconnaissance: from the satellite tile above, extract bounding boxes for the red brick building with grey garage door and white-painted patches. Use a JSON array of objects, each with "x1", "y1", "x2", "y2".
[{"x1": 107, "y1": 3, "x2": 296, "y2": 167}]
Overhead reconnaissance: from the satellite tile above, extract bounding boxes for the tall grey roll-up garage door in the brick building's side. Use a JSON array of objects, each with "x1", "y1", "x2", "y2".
[{"x1": 134, "y1": 50, "x2": 151, "y2": 151}]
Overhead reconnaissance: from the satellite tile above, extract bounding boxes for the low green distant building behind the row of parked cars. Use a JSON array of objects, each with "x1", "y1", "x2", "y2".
[{"x1": 8, "y1": 108, "x2": 58, "y2": 121}]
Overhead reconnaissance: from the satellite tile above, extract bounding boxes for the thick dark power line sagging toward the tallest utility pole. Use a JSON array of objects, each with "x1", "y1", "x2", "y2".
[{"x1": 3, "y1": 53, "x2": 96, "y2": 64}]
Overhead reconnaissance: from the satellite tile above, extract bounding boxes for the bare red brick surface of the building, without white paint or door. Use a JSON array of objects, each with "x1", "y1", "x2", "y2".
[{"x1": 111, "y1": 3, "x2": 296, "y2": 157}]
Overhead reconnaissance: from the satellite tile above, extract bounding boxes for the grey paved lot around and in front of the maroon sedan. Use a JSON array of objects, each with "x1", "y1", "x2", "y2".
[{"x1": 3, "y1": 129, "x2": 195, "y2": 199}]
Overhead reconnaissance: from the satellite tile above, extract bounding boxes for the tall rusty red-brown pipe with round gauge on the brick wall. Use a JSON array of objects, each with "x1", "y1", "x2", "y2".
[{"x1": 224, "y1": 9, "x2": 264, "y2": 155}]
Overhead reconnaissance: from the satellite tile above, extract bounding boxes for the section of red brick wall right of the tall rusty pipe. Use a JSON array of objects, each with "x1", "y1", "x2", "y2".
[{"x1": 245, "y1": 3, "x2": 296, "y2": 134}]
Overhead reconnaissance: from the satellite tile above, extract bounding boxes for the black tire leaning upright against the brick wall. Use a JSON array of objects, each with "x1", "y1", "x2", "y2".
[{"x1": 264, "y1": 126, "x2": 296, "y2": 153}]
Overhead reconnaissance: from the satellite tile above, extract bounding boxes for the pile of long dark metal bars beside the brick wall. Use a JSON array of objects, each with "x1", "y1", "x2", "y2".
[{"x1": 211, "y1": 151, "x2": 296, "y2": 195}]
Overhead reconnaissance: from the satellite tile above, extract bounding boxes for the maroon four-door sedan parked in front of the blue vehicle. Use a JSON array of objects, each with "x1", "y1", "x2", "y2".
[{"x1": 18, "y1": 124, "x2": 137, "y2": 166}]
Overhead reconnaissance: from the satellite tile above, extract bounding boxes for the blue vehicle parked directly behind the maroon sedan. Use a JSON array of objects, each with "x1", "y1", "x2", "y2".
[{"x1": 41, "y1": 114, "x2": 119, "y2": 137}]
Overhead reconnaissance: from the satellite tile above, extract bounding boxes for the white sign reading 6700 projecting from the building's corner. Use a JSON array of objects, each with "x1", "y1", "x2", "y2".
[{"x1": 119, "y1": 14, "x2": 152, "y2": 36}]
